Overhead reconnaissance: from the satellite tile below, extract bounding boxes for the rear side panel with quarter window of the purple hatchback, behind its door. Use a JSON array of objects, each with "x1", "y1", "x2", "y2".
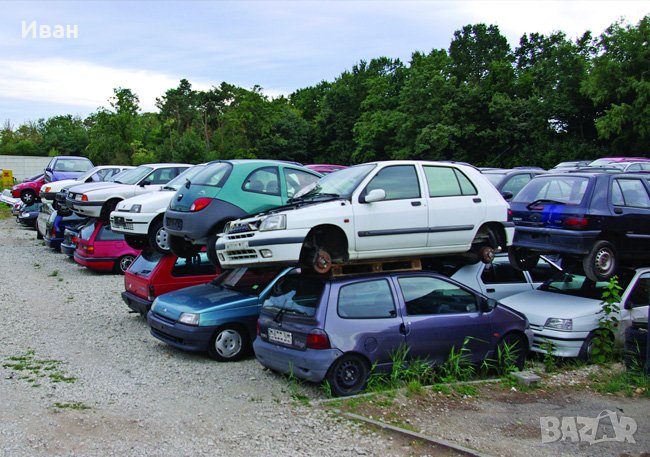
[{"x1": 326, "y1": 278, "x2": 406, "y2": 368}]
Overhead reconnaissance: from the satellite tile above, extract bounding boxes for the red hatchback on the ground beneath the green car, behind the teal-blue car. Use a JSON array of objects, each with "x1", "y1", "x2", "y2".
[{"x1": 122, "y1": 251, "x2": 221, "y2": 316}]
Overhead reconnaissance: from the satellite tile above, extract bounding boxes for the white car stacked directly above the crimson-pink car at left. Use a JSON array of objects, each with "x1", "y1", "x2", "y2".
[{"x1": 66, "y1": 163, "x2": 192, "y2": 220}]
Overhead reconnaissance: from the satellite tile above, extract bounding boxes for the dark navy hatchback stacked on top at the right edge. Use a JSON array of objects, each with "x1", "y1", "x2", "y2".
[{"x1": 509, "y1": 172, "x2": 650, "y2": 281}]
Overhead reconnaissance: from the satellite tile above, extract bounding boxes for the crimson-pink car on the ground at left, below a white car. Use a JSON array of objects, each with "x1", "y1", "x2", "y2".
[{"x1": 74, "y1": 219, "x2": 140, "y2": 274}]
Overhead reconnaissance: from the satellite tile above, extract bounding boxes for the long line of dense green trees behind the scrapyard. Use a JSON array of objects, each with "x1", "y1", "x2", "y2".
[{"x1": 0, "y1": 16, "x2": 650, "y2": 167}]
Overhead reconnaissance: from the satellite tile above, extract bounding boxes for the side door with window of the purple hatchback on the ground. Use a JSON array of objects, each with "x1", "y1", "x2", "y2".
[{"x1": 397, "y1": 275, "x2": 492, "y2": 364}]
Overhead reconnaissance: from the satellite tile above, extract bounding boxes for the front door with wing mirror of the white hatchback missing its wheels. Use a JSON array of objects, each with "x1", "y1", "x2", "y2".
[{"x1": 352, "y1": 165, "x2": 428, "y2": 254}]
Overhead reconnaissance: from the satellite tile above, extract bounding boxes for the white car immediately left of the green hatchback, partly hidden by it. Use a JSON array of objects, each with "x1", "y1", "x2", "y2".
[{"x1": 110, "y1": 164, "x2": 205, "y2": 254}]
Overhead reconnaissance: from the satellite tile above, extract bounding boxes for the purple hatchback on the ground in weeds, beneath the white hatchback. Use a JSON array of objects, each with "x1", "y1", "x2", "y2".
[{"x1": 253, "y1": 271, "x2": 532, "y2": 395}]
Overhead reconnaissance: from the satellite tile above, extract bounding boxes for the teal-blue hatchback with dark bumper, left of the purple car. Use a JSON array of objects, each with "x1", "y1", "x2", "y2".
[{"x1": 147, "y1": 267, "x2": 296, "y2": 361}]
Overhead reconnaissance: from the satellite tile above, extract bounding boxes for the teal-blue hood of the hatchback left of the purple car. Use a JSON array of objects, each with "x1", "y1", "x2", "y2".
[{"x1": 155, "y1": 283, "x2": 258, "y2": 320}]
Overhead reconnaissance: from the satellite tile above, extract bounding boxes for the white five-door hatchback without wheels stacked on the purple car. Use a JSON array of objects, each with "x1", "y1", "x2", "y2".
[{"x1": 216, "y1": 161, "x2": 514, "y2": 273}]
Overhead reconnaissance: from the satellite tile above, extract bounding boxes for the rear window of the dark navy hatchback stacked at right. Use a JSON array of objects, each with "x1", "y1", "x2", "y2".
[{"x1": 512, "y1": 176, "x2": 589, "y2": 205}]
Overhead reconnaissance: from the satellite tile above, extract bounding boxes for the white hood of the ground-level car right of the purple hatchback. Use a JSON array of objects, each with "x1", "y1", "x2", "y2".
[{"x1": 500, "y1": 290, "x2": 602, "y2": 326}]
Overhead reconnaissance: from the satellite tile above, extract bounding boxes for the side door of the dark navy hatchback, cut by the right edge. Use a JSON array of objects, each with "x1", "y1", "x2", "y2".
[{"x1": 611, "y1": 177, "x2": 650, "y2": 259}]
